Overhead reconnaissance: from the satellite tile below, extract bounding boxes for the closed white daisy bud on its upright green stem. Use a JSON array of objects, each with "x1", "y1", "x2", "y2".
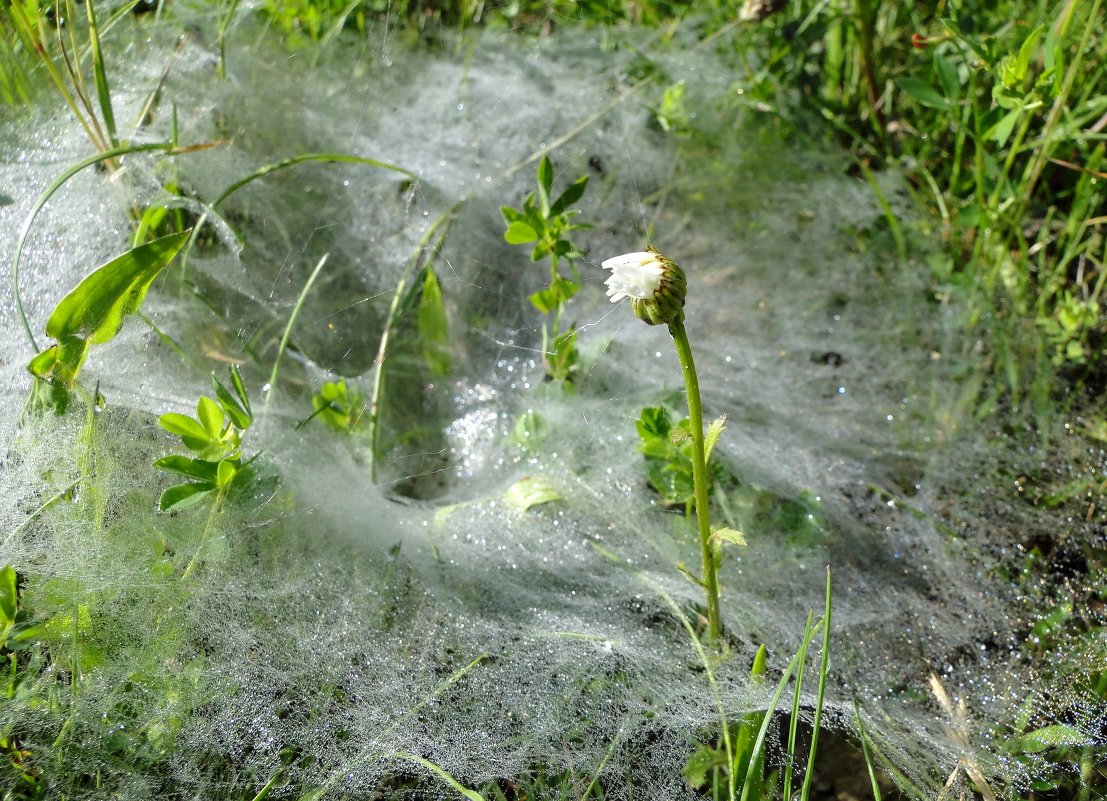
[{"x1": 602, "y1": 246, "x2": 745, "y2": 645}]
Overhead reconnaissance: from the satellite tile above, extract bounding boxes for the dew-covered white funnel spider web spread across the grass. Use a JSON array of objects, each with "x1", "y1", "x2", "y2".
[{"x1": 0, "y1": 10, "x2": 1104, "y2": 799}]
